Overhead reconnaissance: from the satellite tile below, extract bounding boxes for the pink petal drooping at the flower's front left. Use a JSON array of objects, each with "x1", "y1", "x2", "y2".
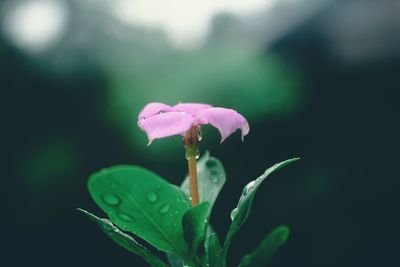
[{"x1": 138, "y1": 111, "x2": 194, "y2": 144}]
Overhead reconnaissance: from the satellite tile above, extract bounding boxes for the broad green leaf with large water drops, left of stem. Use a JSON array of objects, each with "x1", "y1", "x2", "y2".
[{"x1": 88, "y1": 166, "x2": 190, "y2": 257}]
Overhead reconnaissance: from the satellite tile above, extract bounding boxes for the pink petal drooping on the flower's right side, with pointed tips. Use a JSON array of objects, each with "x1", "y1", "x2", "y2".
[{"x1": 196, "y1": 108, "x2": 250, "y2": 143}]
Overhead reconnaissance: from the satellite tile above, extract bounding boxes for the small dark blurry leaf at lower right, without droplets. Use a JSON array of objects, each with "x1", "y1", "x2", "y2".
[{"x1": 239, "y1": 225, "x2": 289, "y2": 267}]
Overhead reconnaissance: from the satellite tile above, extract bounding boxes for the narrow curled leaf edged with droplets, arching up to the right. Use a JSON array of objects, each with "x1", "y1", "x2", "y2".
[{"x1": 223, "y1": 158, "x2": 299, "y2": 257}]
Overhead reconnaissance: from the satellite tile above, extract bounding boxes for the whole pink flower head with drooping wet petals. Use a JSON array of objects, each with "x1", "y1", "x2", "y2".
[{"x1": 138, "y1": 103, "x2": 249, "y2": 144}]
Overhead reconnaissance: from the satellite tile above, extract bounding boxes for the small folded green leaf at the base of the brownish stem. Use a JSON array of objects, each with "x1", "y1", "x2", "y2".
[{"x1": 182, "y1": 202, "x2": 210, "y2": 256}]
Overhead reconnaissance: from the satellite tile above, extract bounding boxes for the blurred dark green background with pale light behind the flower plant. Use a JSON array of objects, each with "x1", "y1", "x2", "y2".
[{"x1": 0, "y1": 0, "x2": 400, "y2": 267}]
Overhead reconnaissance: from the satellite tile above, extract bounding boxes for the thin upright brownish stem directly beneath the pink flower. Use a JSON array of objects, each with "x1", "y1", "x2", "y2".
[{"x1": 183, "y1": 127, "x2": 199, "y2": 206}]
